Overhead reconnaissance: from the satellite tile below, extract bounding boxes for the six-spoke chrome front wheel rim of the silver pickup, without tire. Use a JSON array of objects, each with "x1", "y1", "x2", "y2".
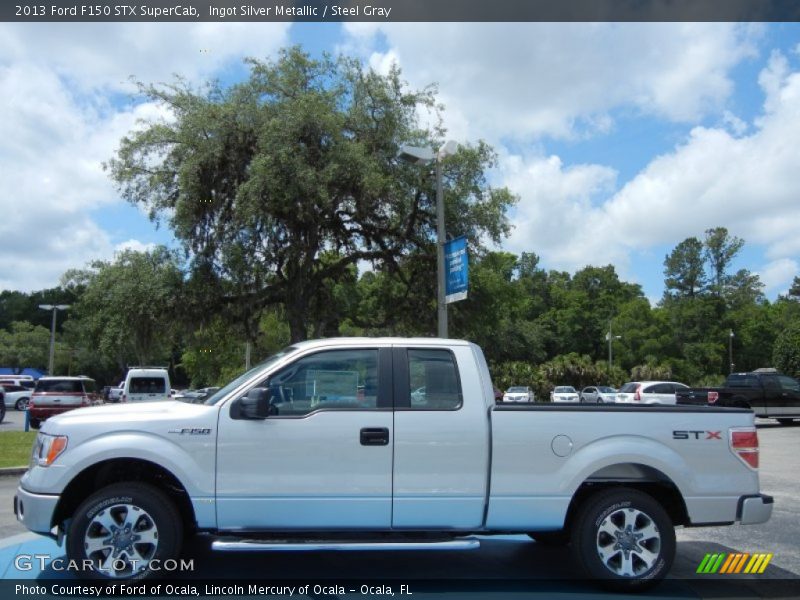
[{"x1": 83, "y1": 504, "x2": 158, "y2": 578}]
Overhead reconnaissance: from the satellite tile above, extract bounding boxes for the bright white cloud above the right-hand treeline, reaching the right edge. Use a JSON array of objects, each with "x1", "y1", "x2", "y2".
[{"x1": 502, "y1": 48, "x2": 800, "y2": 284}]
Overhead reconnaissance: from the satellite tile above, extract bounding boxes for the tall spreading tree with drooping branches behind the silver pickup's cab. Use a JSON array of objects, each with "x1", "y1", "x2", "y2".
[{"x1": 108, "y1": 48, "x2": 513, "y2": 341}]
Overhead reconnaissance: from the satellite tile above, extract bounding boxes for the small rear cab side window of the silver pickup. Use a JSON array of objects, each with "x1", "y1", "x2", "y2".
[{"x1": 408, "y1": 349, "x2": 461, "y2": 410}]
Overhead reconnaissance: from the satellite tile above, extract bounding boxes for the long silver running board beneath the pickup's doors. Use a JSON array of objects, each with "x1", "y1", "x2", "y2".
[{"x1": 211, "y1": 537, "x2": 481, "y2": 552}]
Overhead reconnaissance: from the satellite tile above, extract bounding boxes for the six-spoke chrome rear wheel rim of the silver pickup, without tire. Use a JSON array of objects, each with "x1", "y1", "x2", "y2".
[{"x1": 596, "y1": 508, "x2": 661, "y2": 577}]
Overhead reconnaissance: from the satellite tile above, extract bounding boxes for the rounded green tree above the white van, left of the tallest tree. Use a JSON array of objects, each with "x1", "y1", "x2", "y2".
[{"x1": 62, "y1": 246, "x2": 183, "y2": 369}]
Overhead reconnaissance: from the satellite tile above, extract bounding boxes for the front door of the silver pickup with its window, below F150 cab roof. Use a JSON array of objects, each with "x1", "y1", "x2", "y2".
[{"x1": 217, "y1": 347, "x2": 394, "y2": 530}]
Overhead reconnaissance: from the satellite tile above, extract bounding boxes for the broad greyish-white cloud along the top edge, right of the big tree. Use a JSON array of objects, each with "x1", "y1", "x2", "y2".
[{"x1": 345, "y1": 23, "x2": 759, "y2": 141}]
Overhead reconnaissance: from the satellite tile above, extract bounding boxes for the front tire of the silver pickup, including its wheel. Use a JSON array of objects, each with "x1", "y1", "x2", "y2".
[{"x1": 67, "y1": 483, "x2": 183, "y2": 580}]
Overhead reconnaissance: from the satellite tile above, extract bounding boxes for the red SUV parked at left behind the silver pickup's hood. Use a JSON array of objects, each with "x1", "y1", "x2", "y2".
[{"x1": 28, "y1": 377, "x2": 102, "y2": 429}]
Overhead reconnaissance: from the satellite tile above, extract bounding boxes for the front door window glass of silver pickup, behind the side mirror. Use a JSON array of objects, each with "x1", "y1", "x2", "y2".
[{"x1": 261, "y1": 350, "x2": 378, "y2": 417}]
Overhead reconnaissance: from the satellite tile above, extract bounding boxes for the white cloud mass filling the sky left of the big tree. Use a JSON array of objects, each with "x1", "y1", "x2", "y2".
[{"x1": 0, "y1": 23, "x2": 289, "y2": 291}]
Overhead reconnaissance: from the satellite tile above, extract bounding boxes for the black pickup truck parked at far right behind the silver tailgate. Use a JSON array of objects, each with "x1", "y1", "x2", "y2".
[{"x1": 677, "y1": 370, "x2": 800, "y2": 425}]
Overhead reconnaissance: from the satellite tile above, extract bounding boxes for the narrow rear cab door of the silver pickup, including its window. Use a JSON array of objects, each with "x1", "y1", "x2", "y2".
[{"x1": 392, "y1": 344, "x2": 493, "y2": 530}]
